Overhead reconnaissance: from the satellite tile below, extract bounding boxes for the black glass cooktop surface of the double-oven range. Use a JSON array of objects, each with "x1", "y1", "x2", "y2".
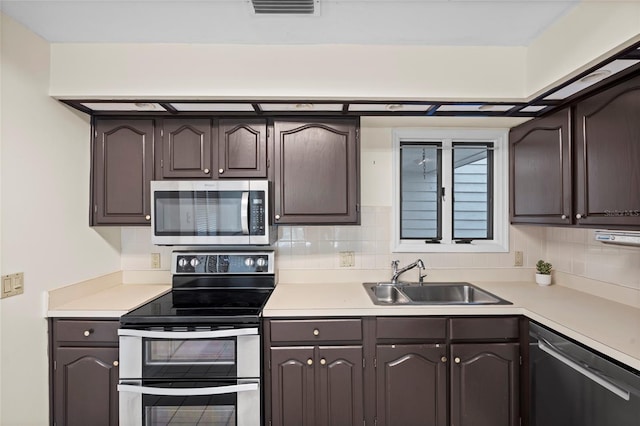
[{"x1": 120, "y1": 288, "x2": 273, "y2": 327}]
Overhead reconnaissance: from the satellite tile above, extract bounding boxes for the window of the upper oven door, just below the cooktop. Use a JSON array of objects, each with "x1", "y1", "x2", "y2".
[{"x1": 142, "y1": 338, "x2": 238, "y2": 379}]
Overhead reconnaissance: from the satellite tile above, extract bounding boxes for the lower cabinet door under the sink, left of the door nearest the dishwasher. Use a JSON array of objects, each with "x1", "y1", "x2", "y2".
[{"x1": 376, "y1": 344, "x2": 444, "y2": 426}]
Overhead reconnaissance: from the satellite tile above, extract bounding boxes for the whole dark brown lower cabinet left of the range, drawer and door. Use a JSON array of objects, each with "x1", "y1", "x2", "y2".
[{"x1": 49, "y1": 319, "x2": 119, "y2": 426}]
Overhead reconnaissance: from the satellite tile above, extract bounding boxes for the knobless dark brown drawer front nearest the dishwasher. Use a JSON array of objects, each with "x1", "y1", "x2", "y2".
[{"x1": 449, "y1": 317, "x2": 520, "y2": 341}]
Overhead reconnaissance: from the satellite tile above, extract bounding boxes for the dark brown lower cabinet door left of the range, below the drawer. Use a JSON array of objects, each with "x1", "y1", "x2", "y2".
[{"x1": 54, "y1": 347, "x2": 118, "y2": 426}]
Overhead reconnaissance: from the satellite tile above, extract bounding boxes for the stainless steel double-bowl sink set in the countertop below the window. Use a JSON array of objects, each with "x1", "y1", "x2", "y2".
[{"x1": 364, "y1": 282, "x2": 511, "y2": 305}]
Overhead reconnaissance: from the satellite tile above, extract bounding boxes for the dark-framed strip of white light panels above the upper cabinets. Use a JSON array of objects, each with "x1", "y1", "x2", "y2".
[{"x1": 61, "y1": 43, "x2": 640, "y2": 117}]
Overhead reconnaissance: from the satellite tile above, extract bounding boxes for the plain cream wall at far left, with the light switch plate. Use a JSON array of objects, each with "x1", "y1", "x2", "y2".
[{"x1": 0, "y1": 15, "x2": 120, "y2": 426}]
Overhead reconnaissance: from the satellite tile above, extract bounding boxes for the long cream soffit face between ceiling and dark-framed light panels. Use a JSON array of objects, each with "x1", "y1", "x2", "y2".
[{"x1": 50, "y1": 44, "x2": 526, "y2": 99}]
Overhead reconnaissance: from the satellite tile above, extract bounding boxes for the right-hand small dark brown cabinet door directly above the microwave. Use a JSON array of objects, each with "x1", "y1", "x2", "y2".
[{"x1": 218, "y1": 119, "x2": 267, "y2": 179}]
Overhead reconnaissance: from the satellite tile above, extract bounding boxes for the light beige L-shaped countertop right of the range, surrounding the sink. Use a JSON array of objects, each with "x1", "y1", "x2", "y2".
[{"x1": 263, "y1": 281, "x2": 640, "y2": 370}]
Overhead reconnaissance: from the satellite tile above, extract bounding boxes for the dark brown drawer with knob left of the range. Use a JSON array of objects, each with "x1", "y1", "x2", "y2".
[{"x1": 53, "y1": 320, "x2": 120, "y2": 344}]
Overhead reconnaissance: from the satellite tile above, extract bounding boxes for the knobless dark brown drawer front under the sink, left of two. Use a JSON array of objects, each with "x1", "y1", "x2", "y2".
[{"x1": 376, "y1": 317, "x2": 447, "y2": 341}]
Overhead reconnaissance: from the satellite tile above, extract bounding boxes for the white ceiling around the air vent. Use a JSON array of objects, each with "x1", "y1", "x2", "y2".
[{"x1": 0, "y1": 0, "x2": 580, "y2": 46}]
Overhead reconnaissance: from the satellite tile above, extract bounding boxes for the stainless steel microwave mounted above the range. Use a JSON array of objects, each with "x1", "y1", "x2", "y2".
[{"x1": 151, "y1": 180, "x2": 277, "y2": 246}]
